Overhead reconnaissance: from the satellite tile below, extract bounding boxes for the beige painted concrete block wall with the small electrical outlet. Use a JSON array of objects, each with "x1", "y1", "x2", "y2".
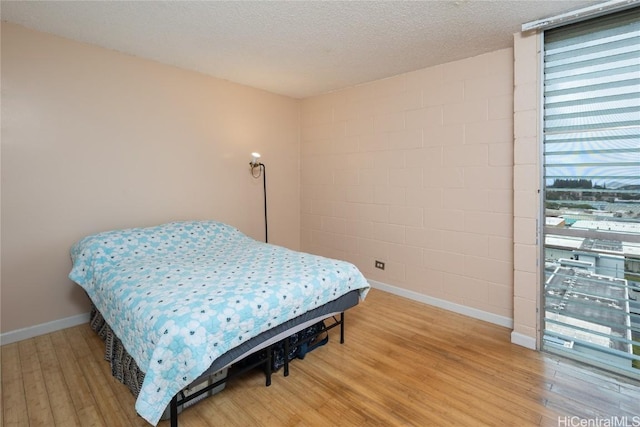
[{"x1": 301, "y1": 49, "x2": 514, "y2": 323}]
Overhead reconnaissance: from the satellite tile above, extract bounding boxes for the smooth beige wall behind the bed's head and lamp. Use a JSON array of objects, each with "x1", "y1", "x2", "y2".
[{"x1": 0, "y1": 23, "x2": 300, "y2": 332}]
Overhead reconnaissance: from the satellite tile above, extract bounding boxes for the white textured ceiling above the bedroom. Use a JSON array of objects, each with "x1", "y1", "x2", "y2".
[{"x1": 0, "y1": 0, "x2": 599, "y2": 98}]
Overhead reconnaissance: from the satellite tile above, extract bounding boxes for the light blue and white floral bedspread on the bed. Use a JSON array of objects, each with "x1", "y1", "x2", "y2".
[{"x1": 69, "y1": 221, "x2": 369, "y2": 425}]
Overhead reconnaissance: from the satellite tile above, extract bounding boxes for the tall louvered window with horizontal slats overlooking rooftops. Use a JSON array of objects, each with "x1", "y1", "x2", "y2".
[{"x1": 543, "y1": 8, "x2": 640, "y2": 372}]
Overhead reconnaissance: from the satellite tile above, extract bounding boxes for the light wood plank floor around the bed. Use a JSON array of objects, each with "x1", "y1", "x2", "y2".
[{"x1": 0, "y1": 290, "x2": 640, "y2": 427}]
